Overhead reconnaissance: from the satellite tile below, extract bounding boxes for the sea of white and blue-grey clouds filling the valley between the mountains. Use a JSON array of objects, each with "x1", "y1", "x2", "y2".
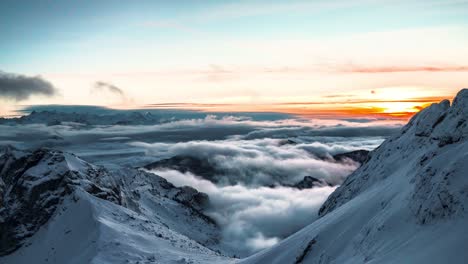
[{"x1": 0, "y1": 107, "x2": 399, "y2": 256}]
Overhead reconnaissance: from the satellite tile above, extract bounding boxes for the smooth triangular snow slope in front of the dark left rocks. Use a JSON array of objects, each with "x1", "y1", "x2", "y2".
[{"x1": 1, "y1": 191, "x2": 230, "y2": 264}]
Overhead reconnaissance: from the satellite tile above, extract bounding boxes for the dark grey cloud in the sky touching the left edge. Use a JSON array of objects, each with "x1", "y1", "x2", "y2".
[{"x1": 0, "y1": 71, "x2": 57, "y2": 101}]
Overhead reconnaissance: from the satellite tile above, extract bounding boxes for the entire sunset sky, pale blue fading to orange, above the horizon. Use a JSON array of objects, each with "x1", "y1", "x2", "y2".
[{"x1": 0, "y1": 0, "x2": 468, "y2": 119}]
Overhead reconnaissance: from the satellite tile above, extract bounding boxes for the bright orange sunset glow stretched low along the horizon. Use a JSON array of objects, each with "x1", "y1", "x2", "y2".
[{"x1": 4, "y1": 89, "x2": 452, "y2": 122}]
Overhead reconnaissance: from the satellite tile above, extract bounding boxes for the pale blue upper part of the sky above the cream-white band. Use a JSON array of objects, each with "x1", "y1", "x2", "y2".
[{"x1": 0, "y1": 0, "x2": 468, "y2": 73}]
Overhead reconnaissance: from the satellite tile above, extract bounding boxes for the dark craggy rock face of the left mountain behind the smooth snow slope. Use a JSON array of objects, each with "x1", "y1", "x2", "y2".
[{"x1": 0, "y1": 148, "x2": 217, "y2": 256}]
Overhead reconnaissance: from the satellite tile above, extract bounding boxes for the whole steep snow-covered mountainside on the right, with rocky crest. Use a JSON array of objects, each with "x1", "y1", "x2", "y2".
[{"x1": 241, "y1": 89, "x2": 468, "y2": 264}]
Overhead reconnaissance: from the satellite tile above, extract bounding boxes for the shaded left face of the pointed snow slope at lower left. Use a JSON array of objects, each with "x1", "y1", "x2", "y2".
[{"x1": 0, "y1": 192, "x2": 99, "y2": 264}]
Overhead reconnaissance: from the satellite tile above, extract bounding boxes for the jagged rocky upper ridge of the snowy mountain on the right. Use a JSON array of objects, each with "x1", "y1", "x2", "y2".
[{"x1": 319, "y1": 89, "x2": 468, "y2": 216}]
